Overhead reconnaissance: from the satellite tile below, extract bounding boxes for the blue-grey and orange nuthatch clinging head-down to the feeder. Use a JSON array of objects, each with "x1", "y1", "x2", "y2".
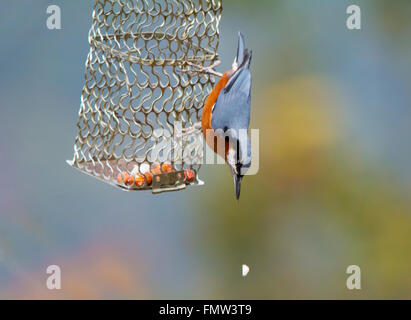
[{"x1": 201, "y1": 32, "x2": 252, "y2": 200}]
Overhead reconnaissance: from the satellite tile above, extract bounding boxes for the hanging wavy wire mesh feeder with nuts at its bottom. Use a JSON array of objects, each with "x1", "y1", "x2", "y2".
[{"x1": 68, "y1": 0, "x2": 222, "y2": 193}]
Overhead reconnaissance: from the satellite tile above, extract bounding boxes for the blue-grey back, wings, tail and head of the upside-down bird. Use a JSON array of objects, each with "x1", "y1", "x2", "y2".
[{"x1": 211, "y1": 33, "x2": 252, "y2": 199}]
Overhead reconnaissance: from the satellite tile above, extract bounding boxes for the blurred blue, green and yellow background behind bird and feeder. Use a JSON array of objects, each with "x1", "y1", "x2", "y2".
[{"x1": 0, "y1": 0, "x2": 411, "y2": 299}]
